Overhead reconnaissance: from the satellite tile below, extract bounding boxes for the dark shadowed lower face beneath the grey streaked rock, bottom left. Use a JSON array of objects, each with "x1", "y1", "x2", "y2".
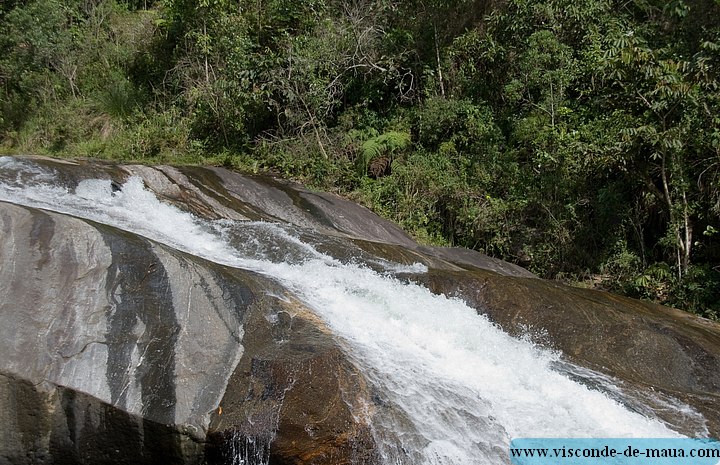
[{"x1": 0, "y1": 374, "x2": 203, "y2": 465}]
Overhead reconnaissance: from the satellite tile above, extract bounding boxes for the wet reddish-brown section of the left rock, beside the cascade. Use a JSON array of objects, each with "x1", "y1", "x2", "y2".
[{"x1": 208, "y1": 300, "x2": 377, "y2": 464}]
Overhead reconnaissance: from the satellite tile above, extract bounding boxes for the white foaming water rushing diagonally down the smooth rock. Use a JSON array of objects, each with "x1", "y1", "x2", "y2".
[{"x1": 0, "y1": 157, "x2": 696, "y2": 465}]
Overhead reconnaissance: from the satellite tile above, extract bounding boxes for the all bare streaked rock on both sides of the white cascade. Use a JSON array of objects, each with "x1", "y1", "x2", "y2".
[{"x1": 0, "y1": 158, "x2": 720, "y2": 465}]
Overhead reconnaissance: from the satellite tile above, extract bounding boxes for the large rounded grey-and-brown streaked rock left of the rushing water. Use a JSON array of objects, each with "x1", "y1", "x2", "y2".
[{"x1": 0, "y1": 202, "x2": 374, "y2": 465}]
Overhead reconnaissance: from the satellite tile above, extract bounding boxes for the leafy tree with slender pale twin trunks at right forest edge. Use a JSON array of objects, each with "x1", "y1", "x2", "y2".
[{"x1": 596, "y1": 10, "x2": 717, "y2": 278}]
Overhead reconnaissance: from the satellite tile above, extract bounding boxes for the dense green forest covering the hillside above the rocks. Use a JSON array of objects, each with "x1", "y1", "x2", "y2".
[{"x1": 0, "y1": 0, "x2": 720, "y2": 318}]
